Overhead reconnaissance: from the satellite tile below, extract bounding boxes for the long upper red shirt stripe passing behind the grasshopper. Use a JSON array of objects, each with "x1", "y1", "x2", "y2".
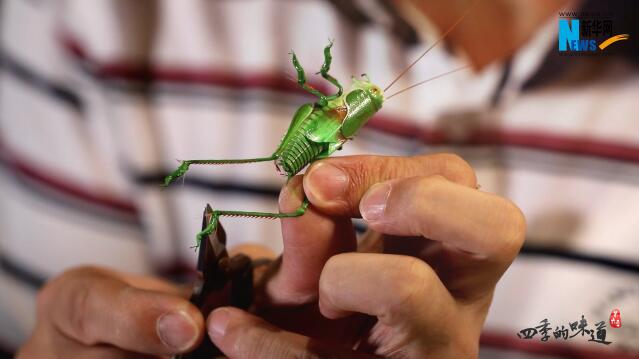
[{"x1": 61, "y1": 33, "x2": 639, "y2": 163}]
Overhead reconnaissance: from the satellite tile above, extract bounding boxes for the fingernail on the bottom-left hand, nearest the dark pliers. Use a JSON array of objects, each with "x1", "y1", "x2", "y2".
[{"x1": 156, "y1": 311, "x2": 197, "y2": 350}]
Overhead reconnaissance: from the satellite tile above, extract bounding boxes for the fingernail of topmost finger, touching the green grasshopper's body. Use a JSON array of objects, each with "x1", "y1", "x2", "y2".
[{"x1": 305, "y1": 162, "x2": 348, "y2": 202}]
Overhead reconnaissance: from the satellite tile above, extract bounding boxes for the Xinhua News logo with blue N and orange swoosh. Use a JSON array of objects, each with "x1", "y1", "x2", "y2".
[{"x1": 558, "y1": 11, "x2": 630, "y2": 55}]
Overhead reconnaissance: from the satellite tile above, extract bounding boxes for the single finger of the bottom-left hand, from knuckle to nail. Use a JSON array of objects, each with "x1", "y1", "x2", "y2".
[{"x1": 38, "y1": 268, "x2": 204, "y2": 355}]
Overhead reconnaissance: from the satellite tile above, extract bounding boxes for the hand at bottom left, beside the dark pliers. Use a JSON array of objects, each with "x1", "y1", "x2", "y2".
[{"x1": 16, "y1": 267, "x2": 204, "y2": 358}]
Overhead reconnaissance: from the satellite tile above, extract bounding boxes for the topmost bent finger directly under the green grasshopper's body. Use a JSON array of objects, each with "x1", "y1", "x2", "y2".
[{"x1": 304, "y1": 153, "x2": 477, "y2": 217}]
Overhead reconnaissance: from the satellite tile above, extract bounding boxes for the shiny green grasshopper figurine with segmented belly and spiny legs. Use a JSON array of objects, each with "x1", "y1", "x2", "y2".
[{"x1": 164, "y1": 41, "x2": 384, "y2": 246}]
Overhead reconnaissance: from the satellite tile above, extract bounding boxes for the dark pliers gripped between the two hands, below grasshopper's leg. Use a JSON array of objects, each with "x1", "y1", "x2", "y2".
[{"x1": 175, "y1": 204, "x2": 253, "y2": 359}]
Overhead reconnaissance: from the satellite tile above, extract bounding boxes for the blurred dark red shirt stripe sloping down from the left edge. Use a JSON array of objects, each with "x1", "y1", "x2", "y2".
[{"x1": 0, "y1": 142, "x2": 138, "y2": 215}]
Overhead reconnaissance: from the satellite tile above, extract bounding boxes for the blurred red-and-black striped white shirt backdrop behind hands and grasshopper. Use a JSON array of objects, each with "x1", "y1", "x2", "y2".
[{"x1": 0, "y1": 0, "x2": 639, "y2": 358}]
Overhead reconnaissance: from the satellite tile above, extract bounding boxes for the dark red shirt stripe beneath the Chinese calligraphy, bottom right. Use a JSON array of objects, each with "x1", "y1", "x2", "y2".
[{"x1": 480, "y1": 331, "x2": 639, "y2": 359}]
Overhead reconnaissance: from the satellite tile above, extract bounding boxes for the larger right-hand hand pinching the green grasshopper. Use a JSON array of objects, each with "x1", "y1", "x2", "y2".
[{"x1": 207, "y1": 154, "x2": 525, "y2": 358}]
